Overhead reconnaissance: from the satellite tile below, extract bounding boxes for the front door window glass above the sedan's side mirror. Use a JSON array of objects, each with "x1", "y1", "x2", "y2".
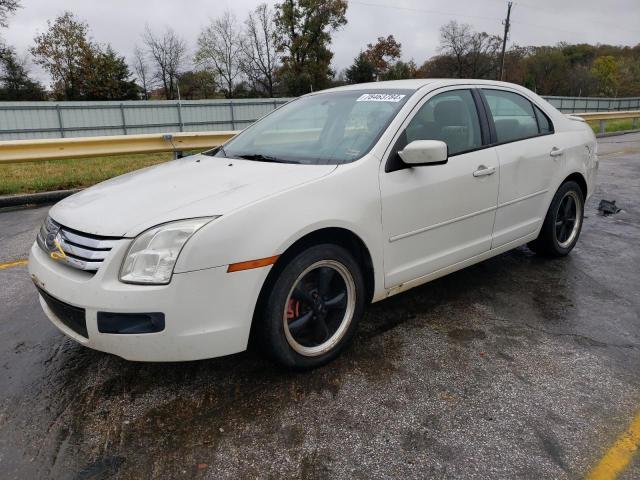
[{"x1": 402, "y1": 90, "x2": 482, "y2": 155}]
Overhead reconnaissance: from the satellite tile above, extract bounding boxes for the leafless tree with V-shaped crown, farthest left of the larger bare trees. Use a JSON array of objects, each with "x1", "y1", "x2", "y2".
[{"x1": 144, "y1": 25, "x2": 187, "y2": 100}]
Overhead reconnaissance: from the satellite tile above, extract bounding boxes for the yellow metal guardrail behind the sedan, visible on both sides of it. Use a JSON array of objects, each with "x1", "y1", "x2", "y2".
[{"x1": 0, "y1": 110, "x2": 640, "y2": 164}]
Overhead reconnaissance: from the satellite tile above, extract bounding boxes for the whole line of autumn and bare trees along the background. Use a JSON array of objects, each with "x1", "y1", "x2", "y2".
[{"x1": 0, "y1": 0, "x2": 640, "y2": 100}]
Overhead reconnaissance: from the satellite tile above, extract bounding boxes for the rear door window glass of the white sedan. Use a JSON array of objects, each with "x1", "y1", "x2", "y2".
[{"x1": 482, "y1": 89, "x2": 538, "y2": 143}]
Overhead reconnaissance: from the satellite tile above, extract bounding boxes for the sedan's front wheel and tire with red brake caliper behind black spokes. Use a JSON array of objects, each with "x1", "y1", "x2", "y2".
[{"x1": 257, "y1": 244, "x2": 366, "y2": 370}]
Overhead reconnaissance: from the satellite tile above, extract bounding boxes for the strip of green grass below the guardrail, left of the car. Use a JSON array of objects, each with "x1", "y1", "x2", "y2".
[{"x1": 0, "y1": 152, "x2": 172, "y2": 195}]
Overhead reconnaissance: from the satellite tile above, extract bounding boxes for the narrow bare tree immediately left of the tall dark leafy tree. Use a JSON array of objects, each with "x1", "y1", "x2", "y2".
[{"x1": 240, "y1": 3, "x2": 279, "y2": 97}]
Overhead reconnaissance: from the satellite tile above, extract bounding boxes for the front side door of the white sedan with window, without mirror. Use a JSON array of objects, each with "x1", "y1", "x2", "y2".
[{"x1": 380, "y1": 88, "x2": 499, "y2": 288}]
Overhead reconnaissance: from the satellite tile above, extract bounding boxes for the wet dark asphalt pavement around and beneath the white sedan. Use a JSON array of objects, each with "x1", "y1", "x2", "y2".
[{"x1": 0, "y1": 135, "x2": 640, "y2": 479}]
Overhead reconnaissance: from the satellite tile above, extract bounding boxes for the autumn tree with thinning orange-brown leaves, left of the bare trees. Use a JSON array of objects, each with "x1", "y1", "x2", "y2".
[{"x1": 30, "y1": 12, "x2": 91, "y2": 100}]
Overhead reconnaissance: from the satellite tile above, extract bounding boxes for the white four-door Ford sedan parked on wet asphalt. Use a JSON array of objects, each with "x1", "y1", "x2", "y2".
[{"x1": 29, "y1": 79, "x2": 598, "y2": 368}]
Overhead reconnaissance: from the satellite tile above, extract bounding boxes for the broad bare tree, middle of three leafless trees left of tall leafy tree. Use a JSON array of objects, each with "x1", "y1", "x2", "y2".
[{"x1": 195, "y1": 10, "x2": 242, "y2": 98}]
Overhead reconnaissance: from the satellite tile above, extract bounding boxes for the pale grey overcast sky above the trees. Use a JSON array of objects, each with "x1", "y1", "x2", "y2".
[{"x1": 0, "y1": 0, "x2": 640, "y2": 85}]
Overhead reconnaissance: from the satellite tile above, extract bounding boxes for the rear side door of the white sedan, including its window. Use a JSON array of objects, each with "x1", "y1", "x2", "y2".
[{"x1": 481, "y1": 87, "x2": 562, "y2": 248}]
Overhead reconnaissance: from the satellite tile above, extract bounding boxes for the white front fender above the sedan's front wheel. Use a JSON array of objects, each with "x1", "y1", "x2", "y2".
[{"x1": 175, "y1": 157, "x2": 382, "y2": 298}]
